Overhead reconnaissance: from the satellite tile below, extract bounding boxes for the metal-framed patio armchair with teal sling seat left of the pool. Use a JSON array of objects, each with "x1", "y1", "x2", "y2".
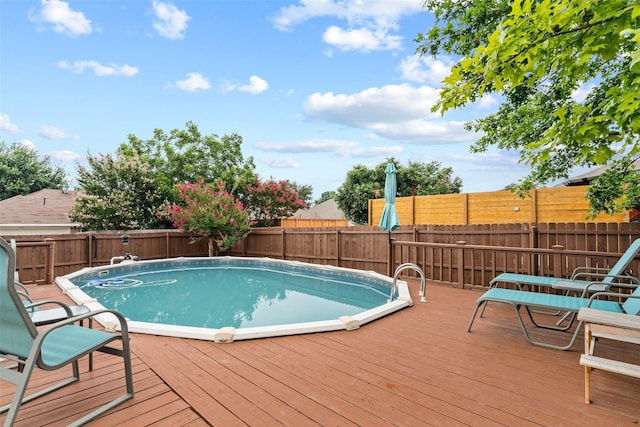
[{"x1": 0, "y1": 239, "x2": 133, "y2": 427}]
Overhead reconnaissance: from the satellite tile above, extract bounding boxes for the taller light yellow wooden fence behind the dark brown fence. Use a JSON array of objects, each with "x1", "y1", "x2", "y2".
[{"x1": 369, "y1": 186, "x2": 629, "y2": 226}]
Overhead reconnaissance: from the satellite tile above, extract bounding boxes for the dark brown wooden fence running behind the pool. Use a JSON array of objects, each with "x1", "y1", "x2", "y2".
[{"x1": 5, "y1": 223, "x2": 640, "y2": 287}]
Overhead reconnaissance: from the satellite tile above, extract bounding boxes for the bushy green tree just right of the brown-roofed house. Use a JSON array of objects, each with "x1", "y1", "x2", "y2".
[{"x1": 70, "y1": 152, "x2": 166, "y2": 231}]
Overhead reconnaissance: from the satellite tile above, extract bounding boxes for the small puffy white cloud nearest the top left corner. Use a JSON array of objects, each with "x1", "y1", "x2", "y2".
[{"x1": 29, "y1": 0, "x2": 93, "y2": 37}]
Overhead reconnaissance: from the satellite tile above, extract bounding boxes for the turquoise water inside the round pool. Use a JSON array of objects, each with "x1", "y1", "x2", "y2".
[{"x1": 74, "y1": 264, "x2": 389, "y2": 328}]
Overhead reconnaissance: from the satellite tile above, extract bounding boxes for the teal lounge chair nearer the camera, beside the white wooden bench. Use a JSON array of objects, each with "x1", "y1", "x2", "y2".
[{"x1": 467, "y1": 284, "x2": 640, "y2": 350}]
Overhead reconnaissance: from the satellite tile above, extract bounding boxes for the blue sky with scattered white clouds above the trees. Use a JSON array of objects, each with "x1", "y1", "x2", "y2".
[{"x1": 0, "y1": 0, "x2": 552, "y2": 198}]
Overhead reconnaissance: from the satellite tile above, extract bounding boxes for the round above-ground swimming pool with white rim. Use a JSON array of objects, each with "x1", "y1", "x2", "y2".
[{"x1": 56, "y1": 257, "x2": 412, "y2": 342}]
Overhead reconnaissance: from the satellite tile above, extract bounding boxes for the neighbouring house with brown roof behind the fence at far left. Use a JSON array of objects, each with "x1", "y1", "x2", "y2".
[{"x1": 0, "y1": 189, "x2": 80, "y2": 236}]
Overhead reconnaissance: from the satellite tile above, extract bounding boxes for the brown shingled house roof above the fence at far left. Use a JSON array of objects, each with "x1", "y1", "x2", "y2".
[{"x1": 0, "y1": 189, "x2": 76, "y2": 225}]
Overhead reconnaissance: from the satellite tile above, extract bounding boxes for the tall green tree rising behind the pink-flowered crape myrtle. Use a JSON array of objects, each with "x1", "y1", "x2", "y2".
[{"x1": 120, "y1": 121, "x2": 255, "y2": 202}]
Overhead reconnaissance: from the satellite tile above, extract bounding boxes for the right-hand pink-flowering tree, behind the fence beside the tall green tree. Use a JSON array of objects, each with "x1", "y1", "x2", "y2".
[{"x1": 246, "y1": 178, "x2": 307, "y2": 227}]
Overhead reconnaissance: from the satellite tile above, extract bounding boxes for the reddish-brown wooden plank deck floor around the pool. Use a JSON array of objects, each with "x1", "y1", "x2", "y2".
[{"x1": 0, "y1": 283, "x2": 640, "y2": 427}]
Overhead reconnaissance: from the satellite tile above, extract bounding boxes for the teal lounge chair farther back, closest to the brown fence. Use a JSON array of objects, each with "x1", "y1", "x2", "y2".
[{"x1": 489, "y1": 239, "x2": 640, "y2": 296}]
